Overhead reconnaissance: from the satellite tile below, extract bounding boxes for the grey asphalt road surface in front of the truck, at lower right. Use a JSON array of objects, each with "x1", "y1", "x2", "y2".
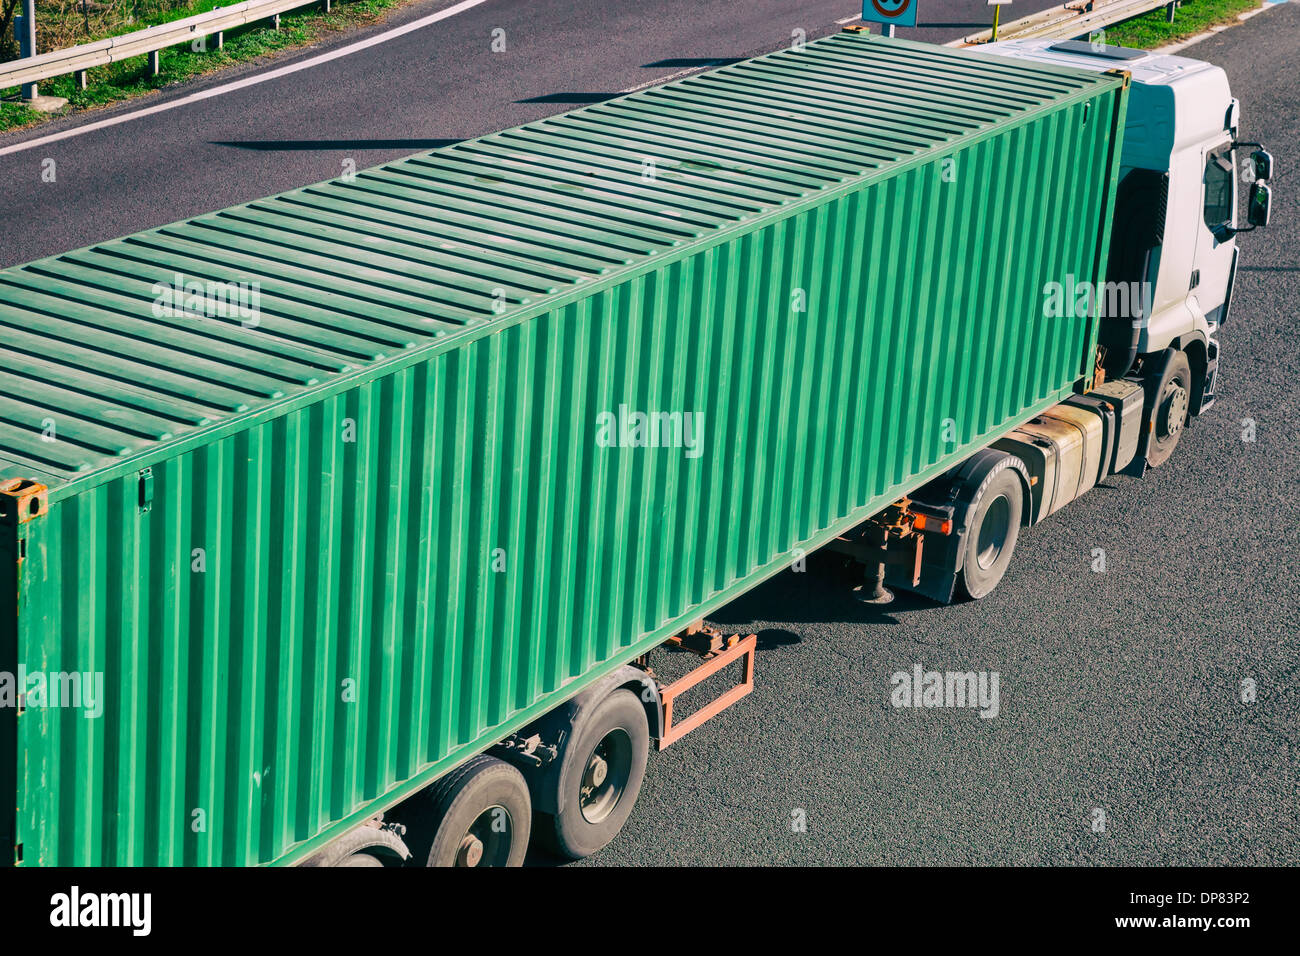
[{"x1": 579, "y1": 3, "x2": 1300, "y2": 865}]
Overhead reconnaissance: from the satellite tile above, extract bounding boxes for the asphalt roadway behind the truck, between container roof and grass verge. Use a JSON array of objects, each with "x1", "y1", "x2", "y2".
[{"x1": 0, "y1": 0, "x2": 1060, "y2": 268}]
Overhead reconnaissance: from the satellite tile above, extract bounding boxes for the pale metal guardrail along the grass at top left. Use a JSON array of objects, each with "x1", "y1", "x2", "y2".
[{"x1": 0, "y1": 0, "x2": 330, "y2": 90}]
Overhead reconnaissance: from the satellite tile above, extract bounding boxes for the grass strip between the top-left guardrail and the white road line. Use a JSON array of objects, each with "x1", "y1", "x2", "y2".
[{"x1": 0, "y1": 0, "x2": 410, "y2": 133}]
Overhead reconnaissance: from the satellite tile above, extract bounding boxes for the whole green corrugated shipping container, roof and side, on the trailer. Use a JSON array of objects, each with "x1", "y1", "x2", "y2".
[{"x1": 0, "y1": 34, "x2": 1127, "y2": 865}]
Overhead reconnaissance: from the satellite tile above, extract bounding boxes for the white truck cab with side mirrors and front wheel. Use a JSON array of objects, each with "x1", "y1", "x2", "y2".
[{"x1": 972, "y1": 40, "x2": 1273, "y2": 464}]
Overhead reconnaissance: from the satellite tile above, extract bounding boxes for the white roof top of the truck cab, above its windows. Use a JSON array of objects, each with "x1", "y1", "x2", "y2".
[{"x1": 970, "y1": 40, "x2": 1236, "y2": 169}]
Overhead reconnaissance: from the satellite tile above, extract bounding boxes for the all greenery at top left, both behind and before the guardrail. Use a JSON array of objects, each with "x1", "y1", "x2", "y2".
[{"x1": 0, "y1": 0, "x2": 408, "y2": 133}]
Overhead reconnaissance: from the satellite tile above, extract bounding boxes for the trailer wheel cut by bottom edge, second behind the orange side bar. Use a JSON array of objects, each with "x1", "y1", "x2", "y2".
[{"x1": 408, "y1": 754, "x2": 533, "y2": 866}]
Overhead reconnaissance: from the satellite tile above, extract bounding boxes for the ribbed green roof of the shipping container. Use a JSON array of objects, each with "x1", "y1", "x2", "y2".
[{"x1": 0, "y1": 33, "x2": 1114, "y2": 494}]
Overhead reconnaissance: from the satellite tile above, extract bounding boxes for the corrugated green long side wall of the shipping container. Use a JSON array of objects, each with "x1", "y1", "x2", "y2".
[{"x1": 0, "y1": 70, "x2": 1123, "y2": 865}]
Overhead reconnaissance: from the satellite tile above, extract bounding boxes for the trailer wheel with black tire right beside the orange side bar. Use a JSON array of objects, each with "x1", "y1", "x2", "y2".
[{"x1": 534, "y1": 689, "x2": 650, "y2": 860}]
